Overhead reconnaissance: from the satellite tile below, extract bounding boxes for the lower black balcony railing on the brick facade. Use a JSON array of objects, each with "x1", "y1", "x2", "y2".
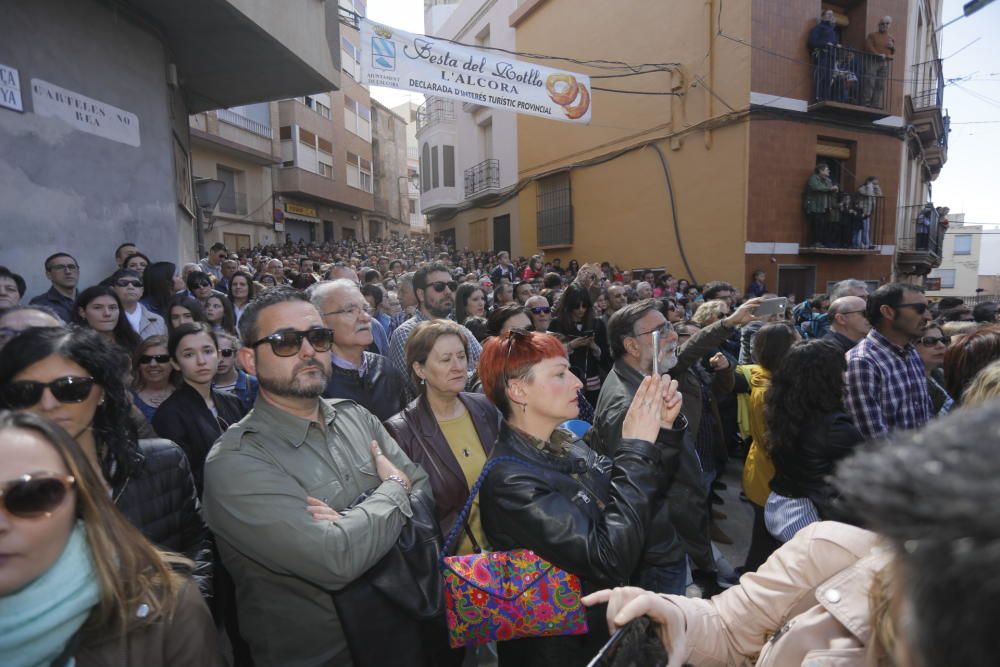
[{"x1": 799, "y1": 190, "x2": 885, "y2": 255}]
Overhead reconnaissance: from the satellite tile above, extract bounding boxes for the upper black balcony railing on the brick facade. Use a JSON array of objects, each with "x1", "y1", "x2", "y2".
[{"x1": 813, "y1": 45, "x2": 892, "y2": 111}]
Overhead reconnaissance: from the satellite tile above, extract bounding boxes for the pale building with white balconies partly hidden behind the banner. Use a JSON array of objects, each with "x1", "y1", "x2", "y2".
[{"x1": 416, "y1": 0, "x2": 521, "y2": 251}]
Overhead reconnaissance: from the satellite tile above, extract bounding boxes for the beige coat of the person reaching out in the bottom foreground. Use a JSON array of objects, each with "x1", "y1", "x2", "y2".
[{"x1": 664, "y1": 521, "x2": 891, "y2": 667}]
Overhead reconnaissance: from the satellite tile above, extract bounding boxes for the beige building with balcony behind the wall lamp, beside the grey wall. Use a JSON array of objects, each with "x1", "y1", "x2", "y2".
[{"x1": 189, "y1": 102, "x2": 281, "y2": 250}]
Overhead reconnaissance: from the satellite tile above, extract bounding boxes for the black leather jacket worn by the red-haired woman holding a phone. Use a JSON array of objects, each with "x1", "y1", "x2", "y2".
[{"x1": 479, "y1": 422, "x2": 683, "y2": 667}]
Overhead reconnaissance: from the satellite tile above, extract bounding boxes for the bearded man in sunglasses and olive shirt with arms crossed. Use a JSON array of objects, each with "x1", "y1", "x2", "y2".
[{"x1": 204, "y1": 287, "x2": 430, "y2": 667}]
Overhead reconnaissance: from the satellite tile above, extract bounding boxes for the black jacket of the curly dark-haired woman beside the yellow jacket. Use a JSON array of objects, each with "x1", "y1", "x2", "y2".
[{"x1": 771, "y1": 412, "x2": 864, "y2": 520}]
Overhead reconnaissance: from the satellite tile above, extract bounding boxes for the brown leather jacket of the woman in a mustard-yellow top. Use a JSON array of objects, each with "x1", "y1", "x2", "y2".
[{"x1": 385, "y1": 392, "x2": 500, "y2": 535}]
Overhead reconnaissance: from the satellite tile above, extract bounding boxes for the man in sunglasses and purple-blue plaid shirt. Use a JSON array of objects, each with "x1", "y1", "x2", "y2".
[{"x1": 846, "y1": 283, "x2": 933, "y2": 439}]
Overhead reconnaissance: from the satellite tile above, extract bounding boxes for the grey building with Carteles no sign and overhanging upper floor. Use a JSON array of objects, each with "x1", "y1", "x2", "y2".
[{"x1": 0, "y1": 0, "x2": 340, "y2": 297}]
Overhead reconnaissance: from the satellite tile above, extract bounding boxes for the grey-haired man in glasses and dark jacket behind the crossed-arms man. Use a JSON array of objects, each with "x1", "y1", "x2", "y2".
[{"x1": 309, "y1": 279, "x2": 406, "y2": 421}]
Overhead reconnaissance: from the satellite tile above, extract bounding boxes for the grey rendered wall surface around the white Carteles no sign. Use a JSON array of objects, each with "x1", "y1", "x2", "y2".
[{"x1": 0, "y1": 0, "x2": 194, "y2": 297}]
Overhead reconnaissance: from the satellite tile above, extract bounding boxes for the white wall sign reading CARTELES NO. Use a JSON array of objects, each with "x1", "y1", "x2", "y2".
[{"x1": 31, "y1": 79, "x2": 140, "y2": 146}]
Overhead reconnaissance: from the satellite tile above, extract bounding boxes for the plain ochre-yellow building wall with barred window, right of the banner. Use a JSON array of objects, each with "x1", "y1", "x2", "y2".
[{"x1": 516, "y1": 0, "x2": 750, "y2": 282}]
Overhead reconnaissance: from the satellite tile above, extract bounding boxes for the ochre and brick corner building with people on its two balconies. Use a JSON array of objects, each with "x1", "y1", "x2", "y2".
[{"x1": 508, "y1": 0, "x2": 946, "y2": 297}]
